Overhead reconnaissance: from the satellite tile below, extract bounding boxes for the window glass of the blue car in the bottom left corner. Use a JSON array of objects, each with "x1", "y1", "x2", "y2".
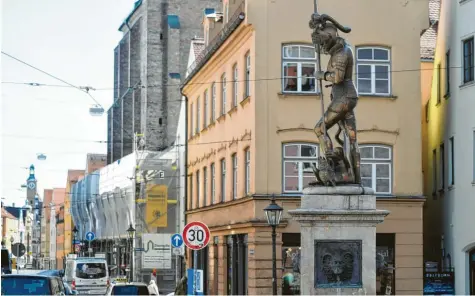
[{"x1": 2, "y1": 277, "x2": 51, "y2": 295}]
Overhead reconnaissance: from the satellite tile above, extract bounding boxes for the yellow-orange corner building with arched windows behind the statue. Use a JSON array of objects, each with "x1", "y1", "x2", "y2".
[{"x1": 182, "y1": 0, "x2": 429, "y2": 295}]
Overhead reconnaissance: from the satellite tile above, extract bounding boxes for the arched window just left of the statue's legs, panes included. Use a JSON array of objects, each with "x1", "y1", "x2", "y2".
[{"x1": 282, "y1": 143, "x2": 319, "y2": 192}]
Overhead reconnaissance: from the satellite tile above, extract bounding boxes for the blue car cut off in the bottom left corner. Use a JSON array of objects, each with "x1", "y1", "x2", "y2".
[{"x1": 2, "y1": 274, "x2": 66, "y2": 296}]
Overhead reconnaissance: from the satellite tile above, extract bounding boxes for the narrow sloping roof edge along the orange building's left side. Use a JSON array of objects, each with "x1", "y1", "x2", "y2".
[{"x1": 182, "y1": 1, "x2": 246, "y2": 86}]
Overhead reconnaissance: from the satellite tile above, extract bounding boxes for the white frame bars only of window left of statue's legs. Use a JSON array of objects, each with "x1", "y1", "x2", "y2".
[{"x1": 282, "y1": 142, "x2": 320, "y2": 193}]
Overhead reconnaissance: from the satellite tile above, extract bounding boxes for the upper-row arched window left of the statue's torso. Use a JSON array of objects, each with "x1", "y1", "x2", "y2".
[{"x1": 282, "y1": 44, "x2": 317, "y2": 93}]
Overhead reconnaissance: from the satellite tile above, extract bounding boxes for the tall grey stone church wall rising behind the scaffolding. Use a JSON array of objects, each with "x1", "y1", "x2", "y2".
[{"x1": 107, "y1": 0, "x2": 220, "y2": 163}]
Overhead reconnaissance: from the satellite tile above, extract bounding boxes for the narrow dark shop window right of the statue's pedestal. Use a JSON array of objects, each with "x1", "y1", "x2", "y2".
[{"x1": 376, "y1": 233, "x2": 396, "y2": 295}]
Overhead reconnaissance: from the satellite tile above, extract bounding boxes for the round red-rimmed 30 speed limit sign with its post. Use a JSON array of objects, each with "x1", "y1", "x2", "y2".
[{"x1": 182, "y1": 221, "x2": 210, "y2": 295}]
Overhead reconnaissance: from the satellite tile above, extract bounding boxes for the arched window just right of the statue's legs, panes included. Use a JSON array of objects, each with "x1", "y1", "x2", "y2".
[{"x1": 360, "y1": 145, "x2": 392, "y2": 194}]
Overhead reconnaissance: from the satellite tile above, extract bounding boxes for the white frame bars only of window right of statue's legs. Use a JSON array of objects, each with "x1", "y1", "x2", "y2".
[{"x1": 360, "y1": 144, "x2": 393, "y2": 195}]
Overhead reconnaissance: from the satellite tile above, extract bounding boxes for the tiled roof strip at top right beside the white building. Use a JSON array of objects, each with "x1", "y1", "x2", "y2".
[{"x1": 420, "y1": 0, "x2": 441, "y2": 60}]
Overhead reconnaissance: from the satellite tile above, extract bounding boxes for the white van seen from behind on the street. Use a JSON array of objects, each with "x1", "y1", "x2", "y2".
[{"x1": 64, "y1": 257, "x2": 110, "y2": 295}]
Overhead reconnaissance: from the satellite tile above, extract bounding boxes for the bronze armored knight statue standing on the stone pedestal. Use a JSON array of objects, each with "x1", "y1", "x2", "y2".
[{"x1": 310, "y1": 13, "x2": 361, "y2": 186}]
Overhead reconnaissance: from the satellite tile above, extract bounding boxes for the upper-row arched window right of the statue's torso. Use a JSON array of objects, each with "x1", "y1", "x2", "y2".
[{"x1": 356, "y1": 47, "x2": 391, "y2": 96}]
